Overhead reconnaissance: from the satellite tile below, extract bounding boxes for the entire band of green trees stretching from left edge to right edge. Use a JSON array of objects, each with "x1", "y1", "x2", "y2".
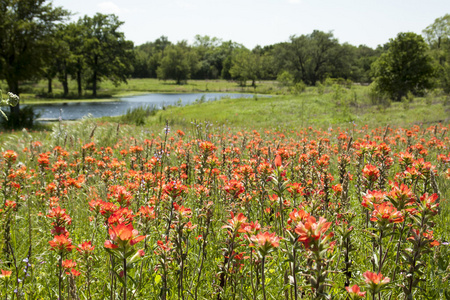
[{"x1": 0, "y1": 0, "x2": 450, "y2": 106}]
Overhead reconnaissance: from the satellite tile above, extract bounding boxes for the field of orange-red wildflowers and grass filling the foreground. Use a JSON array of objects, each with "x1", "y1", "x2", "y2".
[{"x1": 0, "y1": 120, "x2": 450, "y2": 300}]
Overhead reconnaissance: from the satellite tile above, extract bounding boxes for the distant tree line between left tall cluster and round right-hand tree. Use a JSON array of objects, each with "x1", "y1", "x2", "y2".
[{"x1": 132, "y1": 30, "x2": 383, "y2": 85}]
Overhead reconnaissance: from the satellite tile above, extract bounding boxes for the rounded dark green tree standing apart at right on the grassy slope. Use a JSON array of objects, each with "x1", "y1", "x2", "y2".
[{"x1": 372, "y1": 32, "x2": 434, "y2": 101}]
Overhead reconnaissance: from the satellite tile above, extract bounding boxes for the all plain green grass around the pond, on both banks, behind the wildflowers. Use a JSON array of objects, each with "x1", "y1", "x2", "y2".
[{"x1": 0, "y1": 79, "x2": 450, "y2": 129}]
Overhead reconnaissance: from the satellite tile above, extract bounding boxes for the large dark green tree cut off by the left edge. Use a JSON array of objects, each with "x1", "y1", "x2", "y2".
[{"x1": 0, "y1": 0, "x2": 68, "y2": 115}]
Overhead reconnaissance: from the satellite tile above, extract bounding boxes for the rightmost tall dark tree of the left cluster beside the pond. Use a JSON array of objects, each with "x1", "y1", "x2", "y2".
[{"x1": 78, "y1": 13, "x2": 134, "y2": 97}]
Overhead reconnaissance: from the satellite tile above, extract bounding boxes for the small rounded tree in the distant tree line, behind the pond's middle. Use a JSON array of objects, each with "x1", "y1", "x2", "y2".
[{"x1": 157, "y1": 41, "x2": 199, "y2": 84}]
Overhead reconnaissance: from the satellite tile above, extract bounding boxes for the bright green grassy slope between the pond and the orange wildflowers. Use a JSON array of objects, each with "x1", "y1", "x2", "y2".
[{"x1": 148, "y1": 87, "x2": 450, "y2": 129}]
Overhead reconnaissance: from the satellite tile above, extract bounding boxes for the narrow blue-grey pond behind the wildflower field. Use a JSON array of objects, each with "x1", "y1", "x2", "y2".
[{"x1": 31, "y1": 93, "x2": 254, "y2": 120}]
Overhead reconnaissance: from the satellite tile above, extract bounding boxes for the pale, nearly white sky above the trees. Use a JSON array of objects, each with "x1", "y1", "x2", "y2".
[{"x1": 52, "y1": 0, "x2": 450, "y2": 49}]
